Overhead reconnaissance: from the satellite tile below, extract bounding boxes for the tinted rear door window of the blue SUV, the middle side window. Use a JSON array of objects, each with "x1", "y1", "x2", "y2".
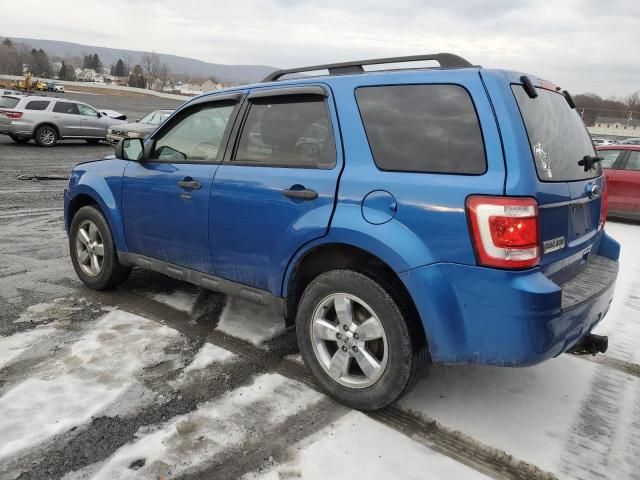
[{"x1": 234, "y1": 95, "x2": 336, "y2": 169}]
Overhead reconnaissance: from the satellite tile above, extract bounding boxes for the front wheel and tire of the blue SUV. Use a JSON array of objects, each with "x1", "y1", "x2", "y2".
[{"x1": 69, "y1": 206, "x2": 131, "y2": 290}]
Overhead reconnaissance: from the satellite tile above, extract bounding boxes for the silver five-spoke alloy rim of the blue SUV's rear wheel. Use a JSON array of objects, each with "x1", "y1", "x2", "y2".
[{"x1": 310, "y1": 293, "x2": 389, "y2": 388}]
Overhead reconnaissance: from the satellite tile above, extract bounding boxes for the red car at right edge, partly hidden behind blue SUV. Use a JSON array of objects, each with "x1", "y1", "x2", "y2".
[{"x1": 598, "y1": 145, "x2": 640, "y2": 220}]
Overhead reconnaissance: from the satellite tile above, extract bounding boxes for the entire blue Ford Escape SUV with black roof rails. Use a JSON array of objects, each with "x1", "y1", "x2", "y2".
[{"x1": 64, "y1": 54, "x2": 619, "y2": 409}]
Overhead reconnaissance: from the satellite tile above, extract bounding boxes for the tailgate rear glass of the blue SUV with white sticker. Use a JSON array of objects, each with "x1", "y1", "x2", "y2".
[{"x1": 511, "y1": 85, "x2": 602, "y2": 182}]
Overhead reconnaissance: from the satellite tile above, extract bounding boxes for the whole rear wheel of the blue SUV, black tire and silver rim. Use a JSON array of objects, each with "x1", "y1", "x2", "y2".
[{"x1": 296, "y1": 270, "x2": 426, "y2": 410}]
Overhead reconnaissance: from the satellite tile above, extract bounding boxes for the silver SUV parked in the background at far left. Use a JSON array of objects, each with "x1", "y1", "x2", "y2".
[{"x1": 0, "y1": 95, "x2": 126, "y2": 147}]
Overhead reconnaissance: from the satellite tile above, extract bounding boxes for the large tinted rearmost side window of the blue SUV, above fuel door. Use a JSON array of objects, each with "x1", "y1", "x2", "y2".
[{"x1": 356, "y1": 85, "x2": 487, "y2": 175}]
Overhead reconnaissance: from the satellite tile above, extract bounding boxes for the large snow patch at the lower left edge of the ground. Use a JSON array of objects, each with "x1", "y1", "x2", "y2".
[{"x1": 0, "y1": 311, "x2": 180, "y2": 459}]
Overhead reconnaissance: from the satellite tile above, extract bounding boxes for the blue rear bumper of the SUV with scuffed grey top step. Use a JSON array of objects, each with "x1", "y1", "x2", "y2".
[{"x1": 400, "y1": 235, "x2": 619, "y2": 366}]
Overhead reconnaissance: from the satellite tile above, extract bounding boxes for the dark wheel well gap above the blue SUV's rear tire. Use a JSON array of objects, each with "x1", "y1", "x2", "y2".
[{"x1": 283, "y1": 242, "x2": 428, "y2": 347}]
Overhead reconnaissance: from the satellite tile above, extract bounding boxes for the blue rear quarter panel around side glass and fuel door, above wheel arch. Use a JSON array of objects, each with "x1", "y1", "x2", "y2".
[{"x1": 318, "y1": 70, "x2": 505, "y2": 272}]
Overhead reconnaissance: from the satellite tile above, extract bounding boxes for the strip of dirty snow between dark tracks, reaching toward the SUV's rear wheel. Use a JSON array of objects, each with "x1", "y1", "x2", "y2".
[{"x1": 71, "y1": 374, "x2": 322, "y2": 480}]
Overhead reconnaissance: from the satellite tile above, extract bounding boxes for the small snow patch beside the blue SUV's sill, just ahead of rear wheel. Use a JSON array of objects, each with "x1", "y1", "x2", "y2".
[{"x1": 217, "y1": 297, "x2": 285, "y2": 346}]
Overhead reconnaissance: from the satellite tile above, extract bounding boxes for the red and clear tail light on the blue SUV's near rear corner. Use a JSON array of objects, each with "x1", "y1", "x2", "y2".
[{"x1": 467, "y1": 196, "x2": 540, "y2": 269}]
